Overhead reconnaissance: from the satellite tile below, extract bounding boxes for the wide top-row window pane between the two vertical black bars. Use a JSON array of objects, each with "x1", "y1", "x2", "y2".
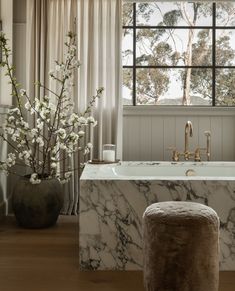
[{"x1": 136, "y1": 2, "x2": 212, "y2": 26}]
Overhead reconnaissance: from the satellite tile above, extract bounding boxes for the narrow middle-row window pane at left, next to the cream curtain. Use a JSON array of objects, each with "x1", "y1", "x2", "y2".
[{"x1": 122, "y1": 29, "x2": 133, "y2": 66}]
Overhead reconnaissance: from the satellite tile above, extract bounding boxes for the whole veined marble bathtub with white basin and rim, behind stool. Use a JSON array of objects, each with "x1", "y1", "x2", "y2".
[{"x1": 79, "y1": 162, "x2": 235, "y2": 270}]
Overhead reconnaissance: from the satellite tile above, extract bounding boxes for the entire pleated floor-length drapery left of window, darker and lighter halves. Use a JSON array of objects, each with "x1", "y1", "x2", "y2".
[{"x1": 26, "y1": 0, "x2": 122, "y2": 215}]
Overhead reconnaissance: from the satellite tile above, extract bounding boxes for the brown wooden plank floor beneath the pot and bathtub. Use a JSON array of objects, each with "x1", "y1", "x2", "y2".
[{"x1": 0, "y1": 216, "x2": 235, "y2": 291}]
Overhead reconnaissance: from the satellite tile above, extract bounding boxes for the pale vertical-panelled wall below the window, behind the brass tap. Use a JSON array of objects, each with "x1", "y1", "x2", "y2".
[{"x1": 123, "y1": 106, "x2": 235, "y2": 161}]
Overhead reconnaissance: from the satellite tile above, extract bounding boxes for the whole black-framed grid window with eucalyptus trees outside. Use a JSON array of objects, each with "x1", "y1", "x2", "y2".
[{"x1": 122, "y1": 2, "x2": 235, "y2": 106}]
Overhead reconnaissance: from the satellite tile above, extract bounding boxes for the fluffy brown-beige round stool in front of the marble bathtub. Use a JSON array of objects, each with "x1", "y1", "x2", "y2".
[{"x1": 143, "y1": 201, "x2": 219, "y2": 291}]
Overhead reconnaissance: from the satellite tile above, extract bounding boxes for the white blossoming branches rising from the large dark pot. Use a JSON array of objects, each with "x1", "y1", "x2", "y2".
[{"x1": 0, "y1": 32, "x2": 103, "y2": 184}]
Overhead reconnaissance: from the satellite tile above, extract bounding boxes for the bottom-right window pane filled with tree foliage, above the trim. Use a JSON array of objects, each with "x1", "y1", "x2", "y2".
[{"x1": 216, "y1": 69, "x2": 235, "y2": 106}]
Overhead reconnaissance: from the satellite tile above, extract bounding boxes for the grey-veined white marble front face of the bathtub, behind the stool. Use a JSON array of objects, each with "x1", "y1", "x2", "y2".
[{"x1": 79, "y1": 165, "x2": 235, "y2": 270}]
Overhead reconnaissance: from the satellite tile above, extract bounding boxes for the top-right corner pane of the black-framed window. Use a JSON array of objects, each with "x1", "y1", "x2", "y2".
[{"x1": 216, "y1": 2, "x2": 235, "y2": 26}]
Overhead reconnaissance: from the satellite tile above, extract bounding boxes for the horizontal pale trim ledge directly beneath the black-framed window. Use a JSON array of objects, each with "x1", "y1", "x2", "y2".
[{"x1": 123, "y1": 105, "x2": 235, "y2": 117}]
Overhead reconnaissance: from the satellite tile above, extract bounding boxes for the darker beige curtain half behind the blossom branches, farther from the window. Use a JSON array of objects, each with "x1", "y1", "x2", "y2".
[{"x1": 26, "y1": 0, "x2": 79, "y2": 214}]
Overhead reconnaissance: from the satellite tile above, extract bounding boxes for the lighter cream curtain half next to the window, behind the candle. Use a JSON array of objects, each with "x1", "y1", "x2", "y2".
[{"x1": 77, "y1": 0, "x2": 122, "y2": 159}]
